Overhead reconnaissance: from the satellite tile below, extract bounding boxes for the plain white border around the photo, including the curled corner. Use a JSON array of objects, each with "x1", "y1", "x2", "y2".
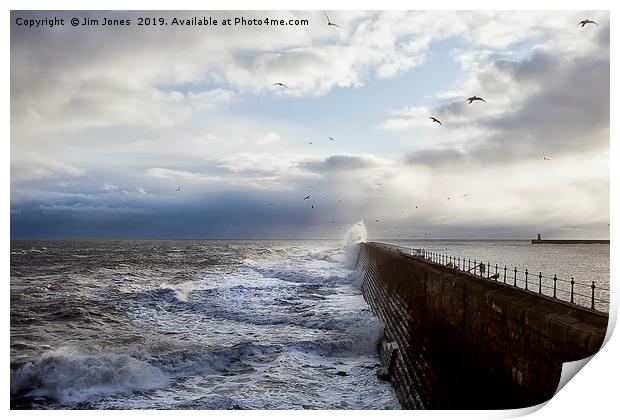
[{"x1": 1, "y1": 0, "x2": 620, "y2": 420}]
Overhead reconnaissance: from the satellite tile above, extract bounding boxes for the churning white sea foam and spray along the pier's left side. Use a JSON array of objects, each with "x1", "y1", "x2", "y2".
[{"x1": 11, "y1": 238, "x2": 398, "y2": 409}]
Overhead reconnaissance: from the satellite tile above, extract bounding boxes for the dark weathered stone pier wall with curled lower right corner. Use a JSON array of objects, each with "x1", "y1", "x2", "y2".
[{"x1": 357, "y1": 243, "x2": 608, "y2": 409}]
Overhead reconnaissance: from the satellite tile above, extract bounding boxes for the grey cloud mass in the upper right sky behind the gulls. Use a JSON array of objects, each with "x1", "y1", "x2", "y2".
[{"x1": 406, "y1": 46, "x2": 610, "y2": 169}]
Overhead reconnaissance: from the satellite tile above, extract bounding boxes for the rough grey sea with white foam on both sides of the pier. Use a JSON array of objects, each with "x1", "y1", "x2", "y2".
[{"x1": 10, "y1": 223, "x2": 609, "y2": 410}]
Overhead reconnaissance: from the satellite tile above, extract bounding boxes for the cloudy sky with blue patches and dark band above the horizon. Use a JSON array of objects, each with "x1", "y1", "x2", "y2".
[{"x1": 11, "y1": 11, "x2": 610, "y2": 238}]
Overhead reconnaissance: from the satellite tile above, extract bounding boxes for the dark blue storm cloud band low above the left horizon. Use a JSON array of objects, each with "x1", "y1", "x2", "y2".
[{"x1": 11, "y1": 192, "x2": 330, "y2": 239}]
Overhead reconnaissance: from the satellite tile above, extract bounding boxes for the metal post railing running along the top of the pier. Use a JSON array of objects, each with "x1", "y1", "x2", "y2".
[{"x1": 375, "y1": 242, "x2": 609, "y2": 312}]
